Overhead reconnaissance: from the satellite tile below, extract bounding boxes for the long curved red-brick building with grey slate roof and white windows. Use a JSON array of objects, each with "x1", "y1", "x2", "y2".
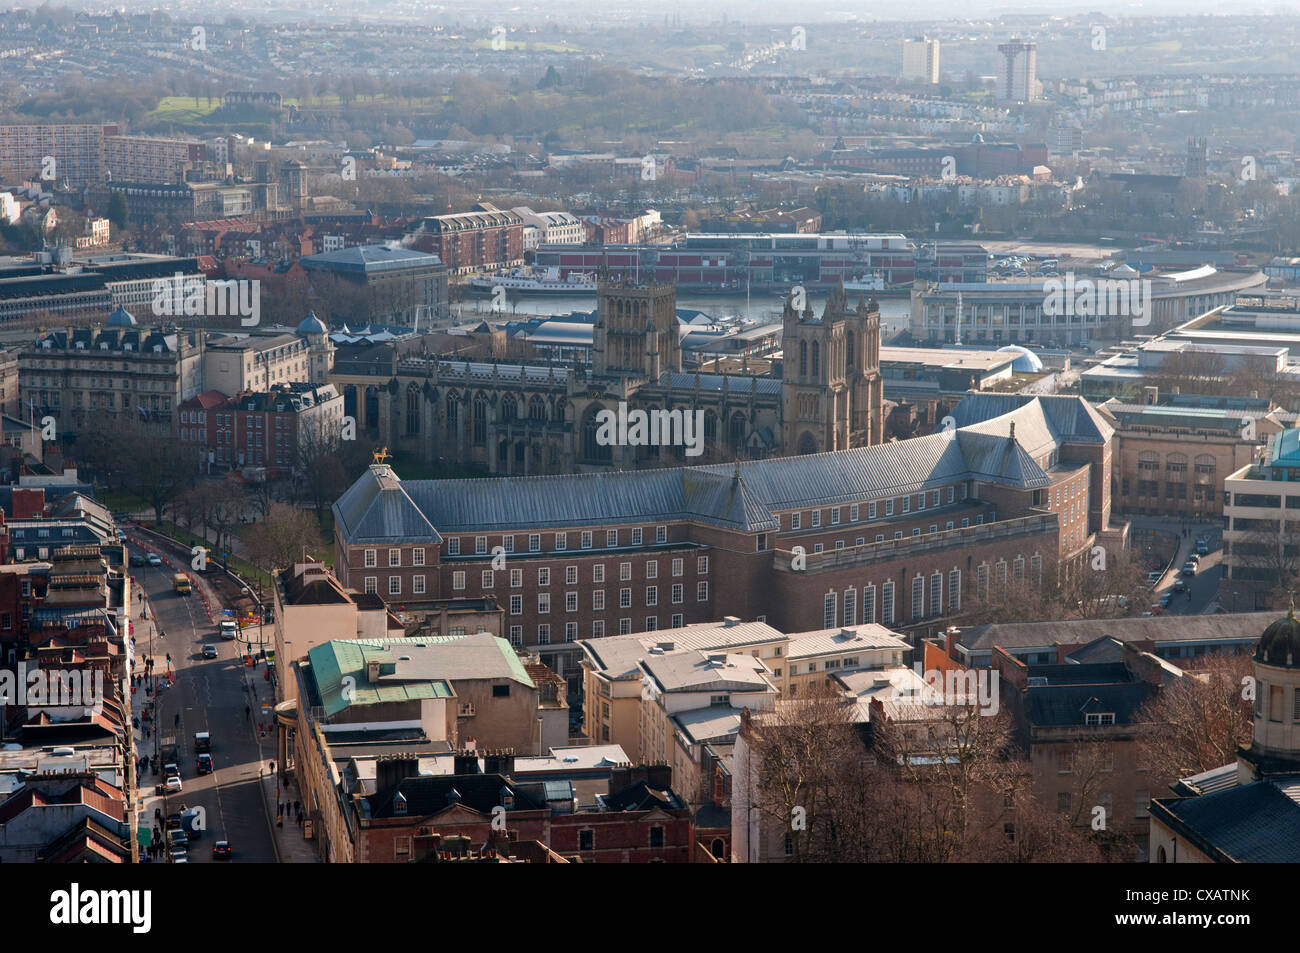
[{"x1": 334, "y1": 394, "x2": 1117, "y2": 693}]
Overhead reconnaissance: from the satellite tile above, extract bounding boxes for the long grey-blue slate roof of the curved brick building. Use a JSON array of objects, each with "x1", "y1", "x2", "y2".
[{"x1": 334, "y1": 395, "x2": 1112, "y2": 545}]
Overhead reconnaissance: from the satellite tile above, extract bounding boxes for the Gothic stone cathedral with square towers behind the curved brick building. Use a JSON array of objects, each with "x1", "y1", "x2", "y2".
[{"x1": 376, "y1": 280, "x2": 884, "y2": 476}]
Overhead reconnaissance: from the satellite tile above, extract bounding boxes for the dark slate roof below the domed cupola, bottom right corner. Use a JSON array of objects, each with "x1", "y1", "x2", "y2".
[{"x1": 1152, "y1": 775, "x2": 1300, "y2": 863}]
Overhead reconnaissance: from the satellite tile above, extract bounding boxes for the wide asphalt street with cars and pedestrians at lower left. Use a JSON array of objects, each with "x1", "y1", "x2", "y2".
[{"x1": 131, "y1": 546, "x2": 277, "y2": 863}]
